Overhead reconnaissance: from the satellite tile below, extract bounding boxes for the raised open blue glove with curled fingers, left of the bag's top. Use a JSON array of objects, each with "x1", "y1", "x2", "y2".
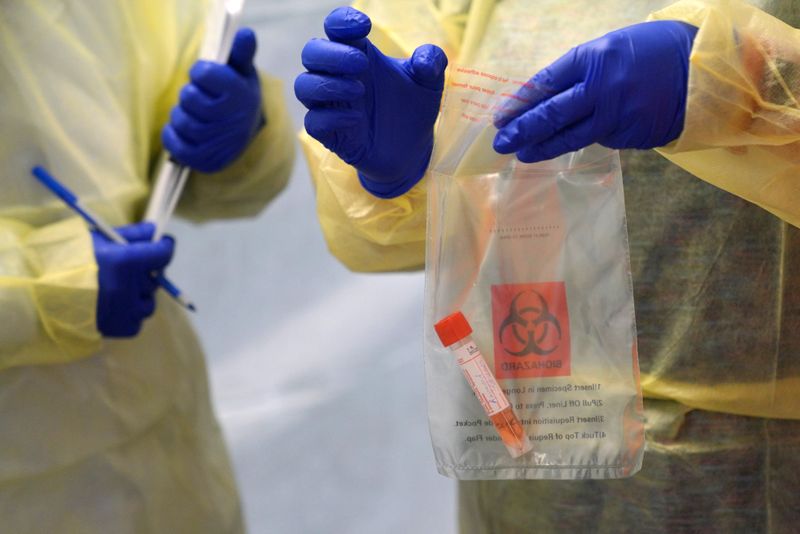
[{"x1": 294, "y1": 7, "x2": 447, "y2": 198}]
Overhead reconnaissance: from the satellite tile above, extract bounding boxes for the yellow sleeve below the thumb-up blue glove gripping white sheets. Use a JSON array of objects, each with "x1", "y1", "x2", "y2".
[{"x1": 178, "y1": 74, "x2": 295, "y2": 221}]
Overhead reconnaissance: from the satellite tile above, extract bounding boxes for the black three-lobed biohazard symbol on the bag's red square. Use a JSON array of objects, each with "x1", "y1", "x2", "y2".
[{"x1": 498, "y1": 289, "x2": 561, "y2": 356}]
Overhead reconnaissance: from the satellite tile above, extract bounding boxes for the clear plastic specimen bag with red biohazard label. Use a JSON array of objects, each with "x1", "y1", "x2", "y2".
[{"x1": 425, "y1": 66, "x2": 644, "y2": 480}]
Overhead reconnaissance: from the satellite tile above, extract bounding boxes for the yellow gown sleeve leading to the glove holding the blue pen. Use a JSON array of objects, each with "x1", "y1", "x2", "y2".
[{"x1": 0, "y1": 217, "x2": 101, "y2": 370}]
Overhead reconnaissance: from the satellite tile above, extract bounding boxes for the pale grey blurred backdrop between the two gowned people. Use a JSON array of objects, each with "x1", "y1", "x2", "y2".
[{"x1": 170, "y1": 0, "x2": 456, "y2": 534}]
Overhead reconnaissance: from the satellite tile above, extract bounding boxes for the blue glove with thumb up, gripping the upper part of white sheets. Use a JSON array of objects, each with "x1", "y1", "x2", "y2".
[{"x1": 161, "y1": 28, "x2": 265, "y2": 173}]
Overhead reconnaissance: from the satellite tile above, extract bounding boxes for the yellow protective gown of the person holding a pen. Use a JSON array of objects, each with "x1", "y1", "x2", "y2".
[{"x1": 0, "y1": 0, "x2": 293, "y2": 534}]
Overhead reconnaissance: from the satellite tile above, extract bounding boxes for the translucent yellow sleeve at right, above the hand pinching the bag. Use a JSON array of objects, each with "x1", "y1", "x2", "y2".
[{"x1": 650, "y1": 0, "x2": 800, "y2": 226}]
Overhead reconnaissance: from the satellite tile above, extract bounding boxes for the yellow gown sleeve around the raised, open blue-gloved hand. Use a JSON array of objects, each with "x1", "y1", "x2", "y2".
[{"x1": 300, "y1": 0, "x2": 470, "y2": 271}]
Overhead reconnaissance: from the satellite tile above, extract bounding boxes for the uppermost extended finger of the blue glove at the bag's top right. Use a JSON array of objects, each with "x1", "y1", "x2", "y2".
[{"x1": 494, "y1": 47, "x2": 584, "y2": 128}]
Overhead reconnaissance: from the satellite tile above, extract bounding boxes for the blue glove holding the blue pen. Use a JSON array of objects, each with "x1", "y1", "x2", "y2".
[{"x1": 92, "y1": 223, "x2": 175, "y2": 337}]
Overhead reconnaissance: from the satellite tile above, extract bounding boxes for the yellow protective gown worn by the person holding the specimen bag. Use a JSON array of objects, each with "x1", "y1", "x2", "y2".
[{"x1": 301, "y1": 0, "x2": 800, "y2": 534}]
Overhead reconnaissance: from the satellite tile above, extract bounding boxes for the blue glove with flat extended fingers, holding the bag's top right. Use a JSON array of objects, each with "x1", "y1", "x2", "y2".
[{"x1": 494, "y1": 21, "x2": 697, "y2": 163}]
